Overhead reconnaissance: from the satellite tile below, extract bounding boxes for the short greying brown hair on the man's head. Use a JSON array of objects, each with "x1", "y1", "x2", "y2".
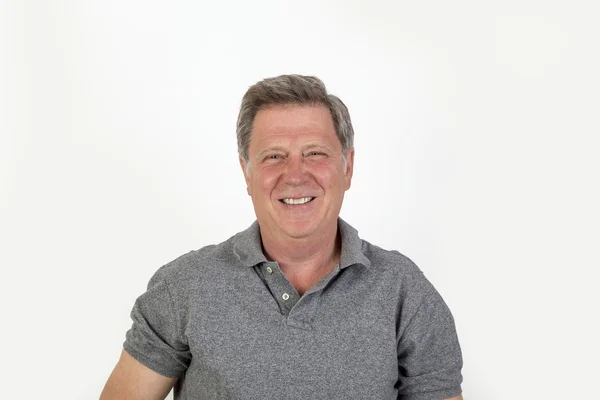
[{"x1": 236, "y1": 75, "x2": 354, "y2": 163}]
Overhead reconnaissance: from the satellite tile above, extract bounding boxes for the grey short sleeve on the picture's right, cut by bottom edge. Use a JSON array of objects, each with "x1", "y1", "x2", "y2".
[{"x1": 398, "y1": 288, "x2": 462, "y2": 400}]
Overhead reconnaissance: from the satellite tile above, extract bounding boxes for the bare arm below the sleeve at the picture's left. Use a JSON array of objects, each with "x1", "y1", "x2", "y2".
[{"x1": 100, "y1": 350, "x2": 177, "y2": 400}]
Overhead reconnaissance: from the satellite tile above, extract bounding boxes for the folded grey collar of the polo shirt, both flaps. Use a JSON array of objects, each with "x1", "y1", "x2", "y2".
[{"x1": 233, "y1": 218, "x2": 371, "y2": 269}]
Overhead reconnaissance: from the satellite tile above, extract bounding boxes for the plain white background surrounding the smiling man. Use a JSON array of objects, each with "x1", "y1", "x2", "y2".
[{"x1": 0, "y1": 0, "x2": 600, "y2": 400}]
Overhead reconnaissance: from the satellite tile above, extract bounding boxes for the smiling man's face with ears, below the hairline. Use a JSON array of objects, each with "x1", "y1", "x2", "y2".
[{"x1": 240, "y1": 105, "x2": 354, "y2": 239}]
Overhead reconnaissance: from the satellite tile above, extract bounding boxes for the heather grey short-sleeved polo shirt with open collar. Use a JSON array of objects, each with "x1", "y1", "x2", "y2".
[{"x1": 124, "y1": 219, "x2": 462, "y2": 400}]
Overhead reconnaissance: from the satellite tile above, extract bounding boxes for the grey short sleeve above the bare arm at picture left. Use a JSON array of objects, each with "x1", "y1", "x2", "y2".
[{"x1": 123, "y1": 269, "x2": 191, "y2": 378}]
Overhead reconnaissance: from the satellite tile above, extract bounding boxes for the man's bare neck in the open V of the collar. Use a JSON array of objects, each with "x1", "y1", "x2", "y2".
[{"x1": 261, "y1": 224, "x2": 341, "y2": 295}]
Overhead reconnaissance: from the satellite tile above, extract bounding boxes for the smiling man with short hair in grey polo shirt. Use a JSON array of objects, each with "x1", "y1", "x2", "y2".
[{"x1": 101, "y1": 75, "x2": 462, "y2": 400}]
